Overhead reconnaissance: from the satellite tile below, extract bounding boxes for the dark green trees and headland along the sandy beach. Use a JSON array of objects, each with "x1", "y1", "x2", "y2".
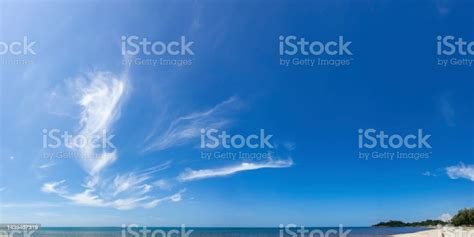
[{"x1": 373, "y1": 208, "x2": 474, "y2": 227}]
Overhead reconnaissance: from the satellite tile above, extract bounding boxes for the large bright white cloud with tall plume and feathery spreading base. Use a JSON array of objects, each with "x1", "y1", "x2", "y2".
[{"x1": 41, "y1": 72, "x2": 182, "y2": 210}]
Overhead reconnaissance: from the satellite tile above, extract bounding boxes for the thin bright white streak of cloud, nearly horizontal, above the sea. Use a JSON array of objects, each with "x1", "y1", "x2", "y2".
[{"x1": 178, "y1": 159, "x2": 293, "y2": 182}]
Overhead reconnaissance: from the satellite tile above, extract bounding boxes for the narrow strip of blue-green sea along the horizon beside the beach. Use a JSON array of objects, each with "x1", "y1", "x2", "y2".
[{"x1": 18, "y1": 227, "x2": 427, "y2": 237}]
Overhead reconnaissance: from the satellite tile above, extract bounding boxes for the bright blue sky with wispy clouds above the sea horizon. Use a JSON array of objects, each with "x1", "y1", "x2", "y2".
[{"x1": 0, "y1": 0, "x2": 474, "y2": 227}]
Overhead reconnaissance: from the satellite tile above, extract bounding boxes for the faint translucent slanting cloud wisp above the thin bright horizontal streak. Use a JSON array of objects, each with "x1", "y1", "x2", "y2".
[{"x1": 144, "y1": 97, "x2": 240, "y2": 152}]
